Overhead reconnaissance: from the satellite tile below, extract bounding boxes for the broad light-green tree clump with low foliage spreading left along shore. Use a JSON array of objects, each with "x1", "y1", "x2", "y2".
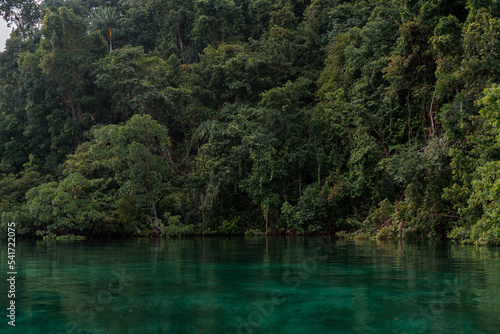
[{"x1": 26, "y1": 115, "x2": 171, "y2": 235}]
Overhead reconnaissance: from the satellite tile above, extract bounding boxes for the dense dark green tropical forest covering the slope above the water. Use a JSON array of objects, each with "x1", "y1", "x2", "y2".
[{"x1": 0, "y1": 0, "x2": 500, "y2": 245}]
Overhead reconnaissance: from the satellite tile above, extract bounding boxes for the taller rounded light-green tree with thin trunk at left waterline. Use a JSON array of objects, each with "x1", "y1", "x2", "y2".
[{"x1": 73, "y1": 115, "x2": 171, "y2": 232}]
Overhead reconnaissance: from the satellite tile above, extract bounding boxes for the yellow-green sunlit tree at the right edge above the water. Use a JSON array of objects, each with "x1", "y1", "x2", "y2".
[{"x1": 446, "y1": 84, "x2": 500, "y2": 245}]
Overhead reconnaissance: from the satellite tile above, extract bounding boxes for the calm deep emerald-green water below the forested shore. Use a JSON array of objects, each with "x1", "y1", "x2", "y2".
[{"x1": 0, "y1": 238, "x2": 500, "y2": 334}]
